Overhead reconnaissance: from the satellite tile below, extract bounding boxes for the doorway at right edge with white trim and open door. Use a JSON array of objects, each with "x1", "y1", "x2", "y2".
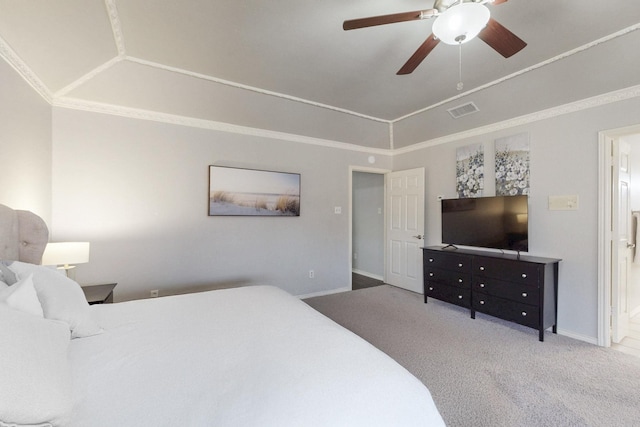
[{"x1": 598, "y1": 125, "x2": 640, "y2": 354}]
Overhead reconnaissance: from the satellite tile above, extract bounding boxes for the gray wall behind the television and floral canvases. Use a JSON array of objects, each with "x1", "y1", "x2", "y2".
[{"x1": 393, "y1": 98, "x2": 640, "y2": 342}]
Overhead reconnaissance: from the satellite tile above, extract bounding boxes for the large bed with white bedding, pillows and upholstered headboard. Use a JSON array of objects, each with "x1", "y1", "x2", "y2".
[{"x1": 0, "y1": 205, "x2": 444, "y2": 427}]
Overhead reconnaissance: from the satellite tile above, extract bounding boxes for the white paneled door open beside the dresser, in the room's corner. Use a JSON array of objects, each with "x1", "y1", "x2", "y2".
[{"x1": 385, "y1": 168, "x2": 424, "y2": 293}]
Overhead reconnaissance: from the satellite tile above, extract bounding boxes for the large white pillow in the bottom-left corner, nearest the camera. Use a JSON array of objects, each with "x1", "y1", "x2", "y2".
[{"x1": 0, "y1": 304, "x2": 72, "y2": 425}]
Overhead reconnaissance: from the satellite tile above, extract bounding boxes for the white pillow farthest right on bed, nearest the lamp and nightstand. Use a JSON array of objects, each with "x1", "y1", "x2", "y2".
[{"x1": 9, "y1": 261, "x2": 102, "y2": 338}]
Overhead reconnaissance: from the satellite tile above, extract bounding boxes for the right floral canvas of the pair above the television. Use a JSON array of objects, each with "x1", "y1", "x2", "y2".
[{"x1": 495, "y1": 133, "x2": 529, "y2": 196}]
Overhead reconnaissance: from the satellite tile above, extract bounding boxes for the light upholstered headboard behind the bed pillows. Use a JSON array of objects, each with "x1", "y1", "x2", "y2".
[{"x1": 0, "y1": 205, "x2": 49, "y2": 264}]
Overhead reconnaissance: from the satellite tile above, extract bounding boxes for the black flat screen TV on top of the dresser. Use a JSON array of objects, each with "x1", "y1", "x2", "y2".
[{"x1": 442, "y1": 196, "x2": 529, "y2": 252}]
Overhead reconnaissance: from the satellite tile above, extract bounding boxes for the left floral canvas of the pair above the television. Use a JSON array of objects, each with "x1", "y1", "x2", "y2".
[{"x1": 456, "y1": 144, "x2": 484, "y2": 198}]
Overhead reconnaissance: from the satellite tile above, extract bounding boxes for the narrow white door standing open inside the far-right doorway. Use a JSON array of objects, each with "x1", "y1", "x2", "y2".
[{"x1": 611, "y1": 139, "x2": 634, "y2": 343}]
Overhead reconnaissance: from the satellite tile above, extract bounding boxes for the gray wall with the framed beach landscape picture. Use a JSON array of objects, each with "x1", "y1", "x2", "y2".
[{"x1": 52, "y1": 108, "x2": 390, "y2": 300}]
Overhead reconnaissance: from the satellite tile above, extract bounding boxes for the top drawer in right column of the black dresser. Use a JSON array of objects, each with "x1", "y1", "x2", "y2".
[{"x1": 473, "y1": 257, "x2": 540, "y2": 286}]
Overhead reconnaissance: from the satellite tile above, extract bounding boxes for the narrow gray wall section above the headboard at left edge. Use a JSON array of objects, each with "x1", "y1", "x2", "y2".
[{"x1": 0, "y1": 60, "x2": 51, "y2": 220}]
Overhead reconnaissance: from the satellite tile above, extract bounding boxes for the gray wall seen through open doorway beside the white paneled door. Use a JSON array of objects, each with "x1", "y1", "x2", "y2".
[{"x1": 352, "y1": 172, "x2": 384, "y2": 280}]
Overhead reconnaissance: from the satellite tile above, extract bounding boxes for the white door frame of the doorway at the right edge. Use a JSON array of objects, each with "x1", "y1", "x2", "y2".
[{"x1": 598, "y1": 124, "x2": 640, "y2": 347}]
